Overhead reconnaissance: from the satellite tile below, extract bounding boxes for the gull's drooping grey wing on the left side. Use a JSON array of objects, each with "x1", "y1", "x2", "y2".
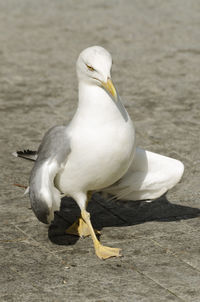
[{"x1": 29, "y1": 126, "x2": 71, "y2": 223}]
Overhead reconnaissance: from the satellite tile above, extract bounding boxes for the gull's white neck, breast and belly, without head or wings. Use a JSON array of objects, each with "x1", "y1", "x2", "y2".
[{"x1": 55, "y1": 83, "x2": 135, "y2": 199}]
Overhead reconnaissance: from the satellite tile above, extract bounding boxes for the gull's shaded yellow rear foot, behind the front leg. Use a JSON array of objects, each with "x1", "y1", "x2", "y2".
[{"x1": 66, "y1": 218, "x2": 101, "y2": 237}]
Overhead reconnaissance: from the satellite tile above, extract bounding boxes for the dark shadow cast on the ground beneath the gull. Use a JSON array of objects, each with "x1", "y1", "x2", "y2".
[{"x1": 48, "y1": 193, "x2": 200, "y2": 245}]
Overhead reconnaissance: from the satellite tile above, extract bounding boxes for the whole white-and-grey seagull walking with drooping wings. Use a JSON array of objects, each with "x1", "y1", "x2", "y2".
[{"x1": 13, "y1": 46, "x2": 184, "y2": 259}]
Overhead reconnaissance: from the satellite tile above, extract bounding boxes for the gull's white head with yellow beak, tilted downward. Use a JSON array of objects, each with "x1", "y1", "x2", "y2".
[{"x1": 76, "y1": 46, "x2": 117, "y2": 101}]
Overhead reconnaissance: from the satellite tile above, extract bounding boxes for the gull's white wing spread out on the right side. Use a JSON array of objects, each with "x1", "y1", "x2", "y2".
[{"x1": 103, "y1": 148, "x2": 184, "y2": 200}]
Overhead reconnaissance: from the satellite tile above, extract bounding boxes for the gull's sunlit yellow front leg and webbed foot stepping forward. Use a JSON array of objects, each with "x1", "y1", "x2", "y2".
[{"x1": 81, "y1": 210, "x2": 121, "y2": 259}]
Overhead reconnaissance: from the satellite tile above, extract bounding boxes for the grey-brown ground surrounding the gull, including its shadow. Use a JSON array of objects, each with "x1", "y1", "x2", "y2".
[{"x1": 0, "y1": 0, "x2": 200, "y2": 302}]
